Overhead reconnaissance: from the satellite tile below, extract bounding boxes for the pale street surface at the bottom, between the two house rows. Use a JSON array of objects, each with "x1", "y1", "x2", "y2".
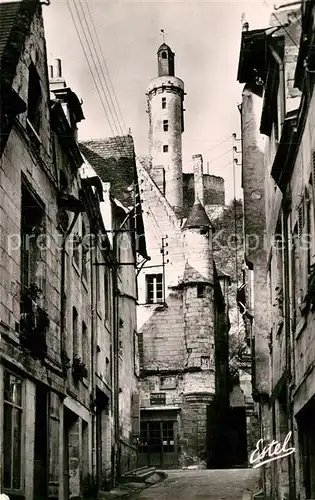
[{"x1": 137, "y1": 469, "x2": 259, "y2": 500}]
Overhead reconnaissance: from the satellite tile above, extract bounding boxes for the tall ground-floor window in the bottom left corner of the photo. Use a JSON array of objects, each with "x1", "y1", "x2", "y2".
[{"x1": 3, "y1": 370, "x2": 23, "y2": 490}]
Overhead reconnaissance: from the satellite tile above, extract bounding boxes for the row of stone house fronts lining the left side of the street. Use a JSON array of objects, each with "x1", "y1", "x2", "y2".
[{"x1": 0, "y1": 0, "x2": 146, "y2": 500}]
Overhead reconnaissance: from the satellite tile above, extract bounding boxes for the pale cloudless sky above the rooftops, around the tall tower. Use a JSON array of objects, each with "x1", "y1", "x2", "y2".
[{"x1": 43, "y1": 0, "x2": 273, "y2": 201}]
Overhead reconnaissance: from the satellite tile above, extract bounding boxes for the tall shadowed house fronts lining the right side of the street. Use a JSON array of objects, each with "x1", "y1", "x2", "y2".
[{"x1": 238, "y1": 6, "x2": 315, "y2": 500}]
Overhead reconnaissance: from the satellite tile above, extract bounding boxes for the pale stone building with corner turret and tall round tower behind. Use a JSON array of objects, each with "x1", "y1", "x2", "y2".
[{"x1": 137, "y1": 44, "x2": 229, "y2": 468}]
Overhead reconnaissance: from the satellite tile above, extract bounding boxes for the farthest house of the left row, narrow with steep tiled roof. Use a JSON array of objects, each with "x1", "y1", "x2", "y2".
[{"x1": 80, "y1": 136, "x2": 147, "y2": 474}]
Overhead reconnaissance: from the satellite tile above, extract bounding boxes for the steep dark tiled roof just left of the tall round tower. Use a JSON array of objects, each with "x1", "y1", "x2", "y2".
[{"x1": 80, "y1": 135, "x2": 137, "y2": 206}]
